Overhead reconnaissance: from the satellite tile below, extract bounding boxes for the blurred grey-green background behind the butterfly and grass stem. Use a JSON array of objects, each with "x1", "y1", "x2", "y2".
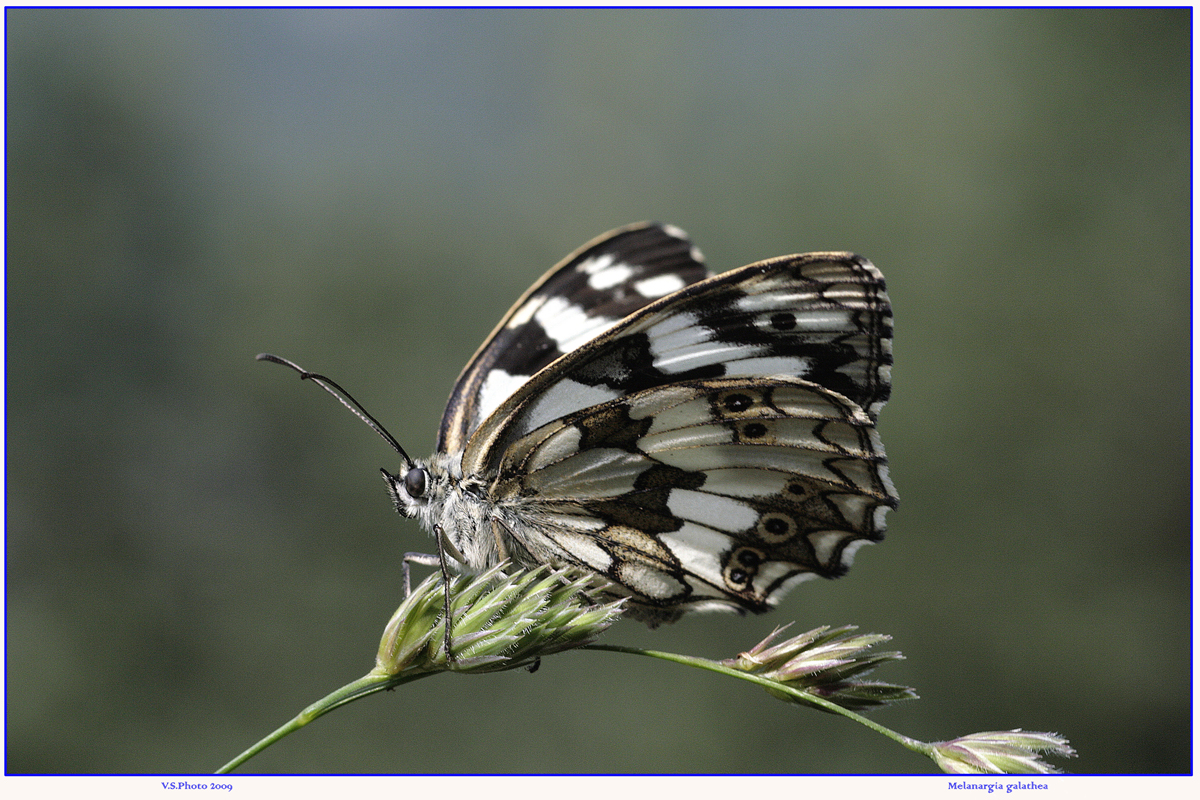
[{"x1": 6, "y1": 10, "x2": 1192, "y2": 774}]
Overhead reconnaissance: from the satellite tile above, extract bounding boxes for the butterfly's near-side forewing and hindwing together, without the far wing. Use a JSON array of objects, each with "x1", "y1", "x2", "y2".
[{"x1": 462, "y1": 253, "x2": 896, "y2": 622}]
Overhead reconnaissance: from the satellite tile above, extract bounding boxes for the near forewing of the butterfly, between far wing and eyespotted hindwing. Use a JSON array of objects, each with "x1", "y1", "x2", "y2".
[{"x1": 463, "y1": 253, "x2": 892, "y2": 473}]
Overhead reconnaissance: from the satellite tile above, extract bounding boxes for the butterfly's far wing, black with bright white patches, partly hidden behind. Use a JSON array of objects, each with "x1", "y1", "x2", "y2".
[{"x1": 438, "y1": 223, "x2": 708, "y2": 452}]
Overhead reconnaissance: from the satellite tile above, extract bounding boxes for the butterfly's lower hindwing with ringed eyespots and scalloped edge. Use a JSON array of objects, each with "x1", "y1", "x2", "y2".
[{"x1": 493, "y1": 378, "x2": 895, "y2": 622}]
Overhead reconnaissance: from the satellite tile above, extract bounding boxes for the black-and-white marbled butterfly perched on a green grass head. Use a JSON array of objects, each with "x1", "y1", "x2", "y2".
[{"x1": 260, "y1": 223, "x2": 896, "y2": 628}]
